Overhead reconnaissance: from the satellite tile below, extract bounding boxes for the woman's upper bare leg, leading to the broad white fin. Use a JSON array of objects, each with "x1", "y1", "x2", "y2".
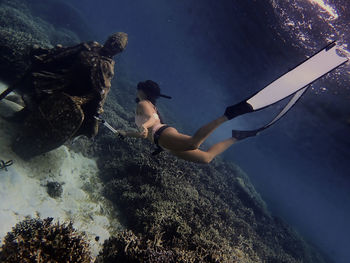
[{"x1": 159, "y1": 116, "x2": 227, "y2": 151}]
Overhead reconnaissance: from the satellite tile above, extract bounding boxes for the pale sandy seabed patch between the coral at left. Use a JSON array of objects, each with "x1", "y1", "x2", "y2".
[{"x1": 0, "y1": 83, "x2": 121, "y2": 255}]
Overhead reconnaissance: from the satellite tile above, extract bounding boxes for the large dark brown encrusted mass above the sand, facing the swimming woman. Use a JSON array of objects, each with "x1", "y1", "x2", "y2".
[{"x1": 9, "y1": 32, "x2": 128, "y2": 158}]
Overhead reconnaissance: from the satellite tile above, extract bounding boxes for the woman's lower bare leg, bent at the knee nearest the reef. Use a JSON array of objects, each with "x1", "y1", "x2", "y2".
[{"x1": 171, "y1": 138, "x2": 237, "y2": 163}]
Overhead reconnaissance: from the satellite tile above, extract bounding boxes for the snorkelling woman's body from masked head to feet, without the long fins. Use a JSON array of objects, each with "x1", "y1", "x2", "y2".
[{"x1": 118, "y1": 80, "x2": 256, "y2": 163}]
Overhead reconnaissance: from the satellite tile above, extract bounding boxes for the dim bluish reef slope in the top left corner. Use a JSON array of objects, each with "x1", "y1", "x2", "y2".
[{"x1": 0, "y1": 0, "x2": 80, "y2": 82}]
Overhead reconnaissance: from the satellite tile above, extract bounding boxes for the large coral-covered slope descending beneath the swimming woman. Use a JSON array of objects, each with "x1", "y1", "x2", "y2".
[{"x1": 72, "y1": 79, "x2": 325, "y2": 263}]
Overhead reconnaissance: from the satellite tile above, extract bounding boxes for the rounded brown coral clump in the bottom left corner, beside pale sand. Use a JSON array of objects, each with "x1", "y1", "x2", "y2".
[{"x1": 0, "y1": 218, "x2": 92, "y2": 263}]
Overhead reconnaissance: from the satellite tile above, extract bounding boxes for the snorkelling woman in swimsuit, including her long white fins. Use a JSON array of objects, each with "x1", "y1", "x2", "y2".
[{"x1": 113, "y1": 42, "x2": 348, "y2": 163}]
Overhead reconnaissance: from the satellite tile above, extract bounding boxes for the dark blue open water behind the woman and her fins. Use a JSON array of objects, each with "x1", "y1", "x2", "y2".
[{"x1": 57, "y1": 0, "x2": 350, "y2": 263}]
